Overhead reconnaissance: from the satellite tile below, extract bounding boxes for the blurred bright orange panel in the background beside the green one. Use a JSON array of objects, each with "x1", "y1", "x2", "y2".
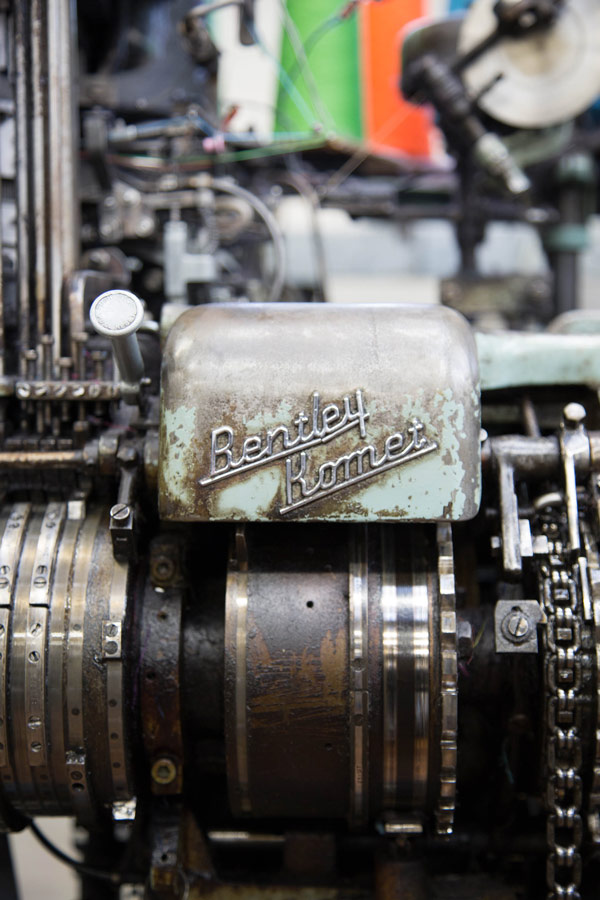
[{"x1": 360, "y1": 0, "x2": 432, "y2": 156}]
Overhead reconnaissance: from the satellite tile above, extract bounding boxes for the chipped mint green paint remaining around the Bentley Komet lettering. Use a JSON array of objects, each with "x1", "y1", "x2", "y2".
[{"x1": 161, "y1": 388, "x2": 480, "y2": 521}]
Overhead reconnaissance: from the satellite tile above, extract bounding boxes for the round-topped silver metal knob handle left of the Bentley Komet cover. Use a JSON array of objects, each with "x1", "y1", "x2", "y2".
[{"x1": 90, "y1": 289, "x2": 144, "y2": 384}]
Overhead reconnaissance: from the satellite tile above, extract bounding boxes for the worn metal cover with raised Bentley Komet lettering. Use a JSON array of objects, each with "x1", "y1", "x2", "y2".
[{"x1": 159, "y1": 304, "x2": 480, "y2": 521}]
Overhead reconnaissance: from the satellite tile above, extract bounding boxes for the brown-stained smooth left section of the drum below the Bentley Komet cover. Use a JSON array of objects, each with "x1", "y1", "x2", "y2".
[{"x1": 225, "y1": 529, "x2": 350, "y2": 817}]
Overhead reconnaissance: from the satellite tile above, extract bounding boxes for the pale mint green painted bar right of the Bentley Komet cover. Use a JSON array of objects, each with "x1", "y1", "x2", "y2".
[{"x1": 475, "y1": 331, "x2": 600, "y2": 391}]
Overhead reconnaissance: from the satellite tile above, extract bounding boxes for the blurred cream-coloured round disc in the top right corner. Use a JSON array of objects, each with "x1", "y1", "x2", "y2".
[{"x1": 458, "y1": 0, "x2": 600, "y2": 128}]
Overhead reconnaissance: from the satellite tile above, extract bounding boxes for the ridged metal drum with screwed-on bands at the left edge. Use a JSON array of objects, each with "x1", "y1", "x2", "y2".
[{"x1": 0, "y1": 502, "x2": 131, "y2": 823}]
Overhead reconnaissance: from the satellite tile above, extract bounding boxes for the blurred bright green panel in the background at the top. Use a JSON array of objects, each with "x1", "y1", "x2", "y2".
[{"x1": 276, "y1": 0, "x2": 363, "y2": 139}]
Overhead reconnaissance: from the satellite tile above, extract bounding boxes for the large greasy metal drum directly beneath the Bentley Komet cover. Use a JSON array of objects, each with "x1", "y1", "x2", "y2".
[{"x1": 225, "y1": 525, "x2": 449, "y2": 825}]
